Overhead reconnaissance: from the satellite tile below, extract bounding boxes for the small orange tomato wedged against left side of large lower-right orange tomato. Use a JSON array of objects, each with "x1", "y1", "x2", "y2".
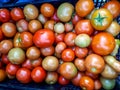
[{"x1": 74, "y1": 58, "x2": 86, "y2": 71}]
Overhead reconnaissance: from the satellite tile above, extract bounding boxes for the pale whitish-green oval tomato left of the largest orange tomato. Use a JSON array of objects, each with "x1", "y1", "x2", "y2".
[{"x1": 75, "y1": 34, "x2": 91, "y2": 48}]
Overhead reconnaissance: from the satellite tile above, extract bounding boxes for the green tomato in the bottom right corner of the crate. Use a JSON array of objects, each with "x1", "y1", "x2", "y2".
[{"x1": 100, "y1": 77, "x2": 115, "y2": 90}]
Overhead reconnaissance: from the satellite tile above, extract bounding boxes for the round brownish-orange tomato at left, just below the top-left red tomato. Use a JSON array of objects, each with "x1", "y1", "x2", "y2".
[{"x1": 1, "y1": 22, "x2": 17, "y2": 37}]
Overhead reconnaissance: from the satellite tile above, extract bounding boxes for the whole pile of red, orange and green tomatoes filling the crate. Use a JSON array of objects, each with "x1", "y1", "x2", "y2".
[{"x1": 0, "y1": 0, "x2": 120, "y2": 90}]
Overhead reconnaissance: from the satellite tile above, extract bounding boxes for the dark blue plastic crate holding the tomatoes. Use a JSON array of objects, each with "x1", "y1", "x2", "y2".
[{"x1": 0, "y1": 0, "x2": 120, "y2": 90}]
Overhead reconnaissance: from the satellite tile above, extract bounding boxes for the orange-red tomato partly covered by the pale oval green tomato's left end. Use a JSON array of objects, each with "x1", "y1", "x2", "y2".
[{"x1": 64, "y1": 32, "x2": 77, "y2": 46}]
